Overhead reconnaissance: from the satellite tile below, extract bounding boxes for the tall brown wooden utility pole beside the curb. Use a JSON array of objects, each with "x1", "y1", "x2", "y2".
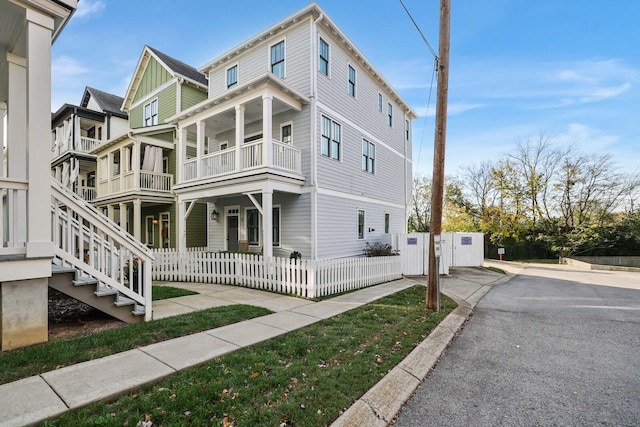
[{"x1": 427, "y1": 0, "x2": 450, "y2": 312}]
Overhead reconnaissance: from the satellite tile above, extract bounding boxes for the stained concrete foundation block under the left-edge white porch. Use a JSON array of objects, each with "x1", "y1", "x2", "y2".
[{"x1": 0, "y1": 277, "x2": 48, "y2": 351}]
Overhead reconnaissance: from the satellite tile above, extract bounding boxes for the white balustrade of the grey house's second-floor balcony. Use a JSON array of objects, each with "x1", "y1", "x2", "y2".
[{"x1": 183, "y1": 139, "x2": 302, "y2": 181}]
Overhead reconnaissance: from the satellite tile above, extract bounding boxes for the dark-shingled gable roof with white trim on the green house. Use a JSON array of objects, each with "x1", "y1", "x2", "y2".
[{"x1": 121, "y1": 45, "x2": 208, "y2": 111}]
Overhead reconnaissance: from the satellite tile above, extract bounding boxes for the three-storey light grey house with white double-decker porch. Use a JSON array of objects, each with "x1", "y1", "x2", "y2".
[{"x1": 167, "y1": 3, "x2": 416, "y2": 259}]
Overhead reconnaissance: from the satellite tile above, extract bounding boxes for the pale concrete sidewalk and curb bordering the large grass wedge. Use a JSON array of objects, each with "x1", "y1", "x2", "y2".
[{"x1": 0, "y1": 264, "x2": 512, "y2": 426}]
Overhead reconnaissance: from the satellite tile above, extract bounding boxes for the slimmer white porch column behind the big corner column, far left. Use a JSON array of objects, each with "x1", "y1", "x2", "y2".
[{"x1": 7, "y1": 53, "x2": 27, "y2": 245}]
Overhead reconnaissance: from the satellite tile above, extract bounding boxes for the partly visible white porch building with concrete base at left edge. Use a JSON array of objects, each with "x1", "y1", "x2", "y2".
[{"x1": 0, "y1": 0, "x2": 77, "y2": 350}]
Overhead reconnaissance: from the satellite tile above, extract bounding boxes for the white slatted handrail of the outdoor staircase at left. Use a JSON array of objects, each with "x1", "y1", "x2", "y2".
[{"x1": 51, "y1": 178, "x2": 154, "y2": 320}]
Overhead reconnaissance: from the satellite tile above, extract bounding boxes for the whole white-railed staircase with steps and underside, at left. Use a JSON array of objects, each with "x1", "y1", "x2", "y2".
[{"x1": 49, "y1": 179, "x2": 153, "y2": 323}]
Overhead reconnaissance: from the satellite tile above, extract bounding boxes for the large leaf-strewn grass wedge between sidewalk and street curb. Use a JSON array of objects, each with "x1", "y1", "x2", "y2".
[{"x1": 45, "y1": 286, "x2": 456, "y2": 427}]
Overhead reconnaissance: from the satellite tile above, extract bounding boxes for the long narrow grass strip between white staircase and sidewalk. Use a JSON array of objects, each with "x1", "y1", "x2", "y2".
[{"x1": 0, "y1": 305, "x2": 271, "y2": 384}]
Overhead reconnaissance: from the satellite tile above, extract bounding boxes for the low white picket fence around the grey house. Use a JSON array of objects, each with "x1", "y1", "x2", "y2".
[{"x1": 152, "y1": 248, "x2": 402, "y2": 298}]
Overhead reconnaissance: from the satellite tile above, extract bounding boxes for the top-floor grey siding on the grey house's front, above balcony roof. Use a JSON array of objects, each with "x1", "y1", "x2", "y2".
[{"x1": 209, "y1": 20, "x2": 312, "y2": 98}]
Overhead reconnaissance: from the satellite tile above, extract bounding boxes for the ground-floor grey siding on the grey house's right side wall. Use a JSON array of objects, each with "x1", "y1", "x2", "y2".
[{"x1": 317, "y1": 194, "x2": 406, "y2": 259}]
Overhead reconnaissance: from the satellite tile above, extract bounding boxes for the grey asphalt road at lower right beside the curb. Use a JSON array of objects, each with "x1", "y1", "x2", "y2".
[{"x1": 395, "y1": 266, "x2": 640, "y2": 427}]
